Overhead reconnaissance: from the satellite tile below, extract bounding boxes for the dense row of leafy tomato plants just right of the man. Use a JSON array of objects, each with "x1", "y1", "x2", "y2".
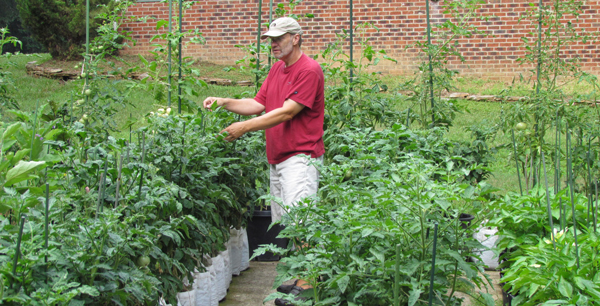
[{"x1": 254, "y1": 125, "x2": 494, "y2": 305}]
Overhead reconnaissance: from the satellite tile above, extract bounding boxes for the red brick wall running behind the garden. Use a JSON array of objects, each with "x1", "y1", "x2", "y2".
[{"x1": 123, "y1": 0, "x2": 600, "y2": 78}]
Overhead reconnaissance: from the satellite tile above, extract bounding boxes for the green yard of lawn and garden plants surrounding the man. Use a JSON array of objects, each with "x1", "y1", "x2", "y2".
[{"x1": 0, "y1": 0, "x2": 600, "y2": 306}]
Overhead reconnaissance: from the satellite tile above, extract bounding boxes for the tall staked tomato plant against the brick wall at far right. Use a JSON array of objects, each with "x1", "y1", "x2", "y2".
[{"x1": 502, "y1": 0, "x2": 598, "y2": 188}]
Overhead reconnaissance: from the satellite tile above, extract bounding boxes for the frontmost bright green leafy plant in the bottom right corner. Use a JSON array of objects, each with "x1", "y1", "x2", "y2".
[{"x1": 501, "y1": 228, "x2": 600, "y2": 305}]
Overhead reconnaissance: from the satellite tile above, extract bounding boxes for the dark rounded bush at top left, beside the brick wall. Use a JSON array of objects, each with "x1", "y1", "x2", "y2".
[{"x1": 17, "y1": 0, "x2": 112, "y2": 59}]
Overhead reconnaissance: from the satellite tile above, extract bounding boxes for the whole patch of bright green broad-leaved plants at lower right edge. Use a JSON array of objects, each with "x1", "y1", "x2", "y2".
[{"x1": 489, "y1": 183, "x2": 599, "y2": 305}]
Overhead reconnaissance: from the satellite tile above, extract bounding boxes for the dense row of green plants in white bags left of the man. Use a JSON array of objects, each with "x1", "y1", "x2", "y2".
[{"x1": 0, "y1": 106, "x2": 266, "y2": 305}]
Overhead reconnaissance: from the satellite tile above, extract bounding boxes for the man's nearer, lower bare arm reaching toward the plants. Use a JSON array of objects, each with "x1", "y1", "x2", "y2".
[{"x1": 221, "y1": 99, "x2": 304, "y2": 141}]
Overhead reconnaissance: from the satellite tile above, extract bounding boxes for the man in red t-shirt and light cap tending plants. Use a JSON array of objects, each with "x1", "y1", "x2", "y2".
[{"x1": 204, "y1": 17, "x2": 325, "y2": 305}]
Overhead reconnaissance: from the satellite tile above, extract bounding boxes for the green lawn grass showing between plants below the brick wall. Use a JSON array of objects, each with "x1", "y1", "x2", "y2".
[{"x1": 0, "y1": 54, "x2": 590, "y2": 193}]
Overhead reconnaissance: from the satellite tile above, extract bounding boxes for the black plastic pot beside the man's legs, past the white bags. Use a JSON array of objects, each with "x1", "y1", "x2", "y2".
[{"x1": 247, "y1": 210, "x2": 288, "y2": 261}]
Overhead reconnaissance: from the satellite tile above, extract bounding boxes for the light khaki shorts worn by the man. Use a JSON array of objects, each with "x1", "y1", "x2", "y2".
[{"x1": 270, "y1": 155, "x2": 323, "y2": 222}]
